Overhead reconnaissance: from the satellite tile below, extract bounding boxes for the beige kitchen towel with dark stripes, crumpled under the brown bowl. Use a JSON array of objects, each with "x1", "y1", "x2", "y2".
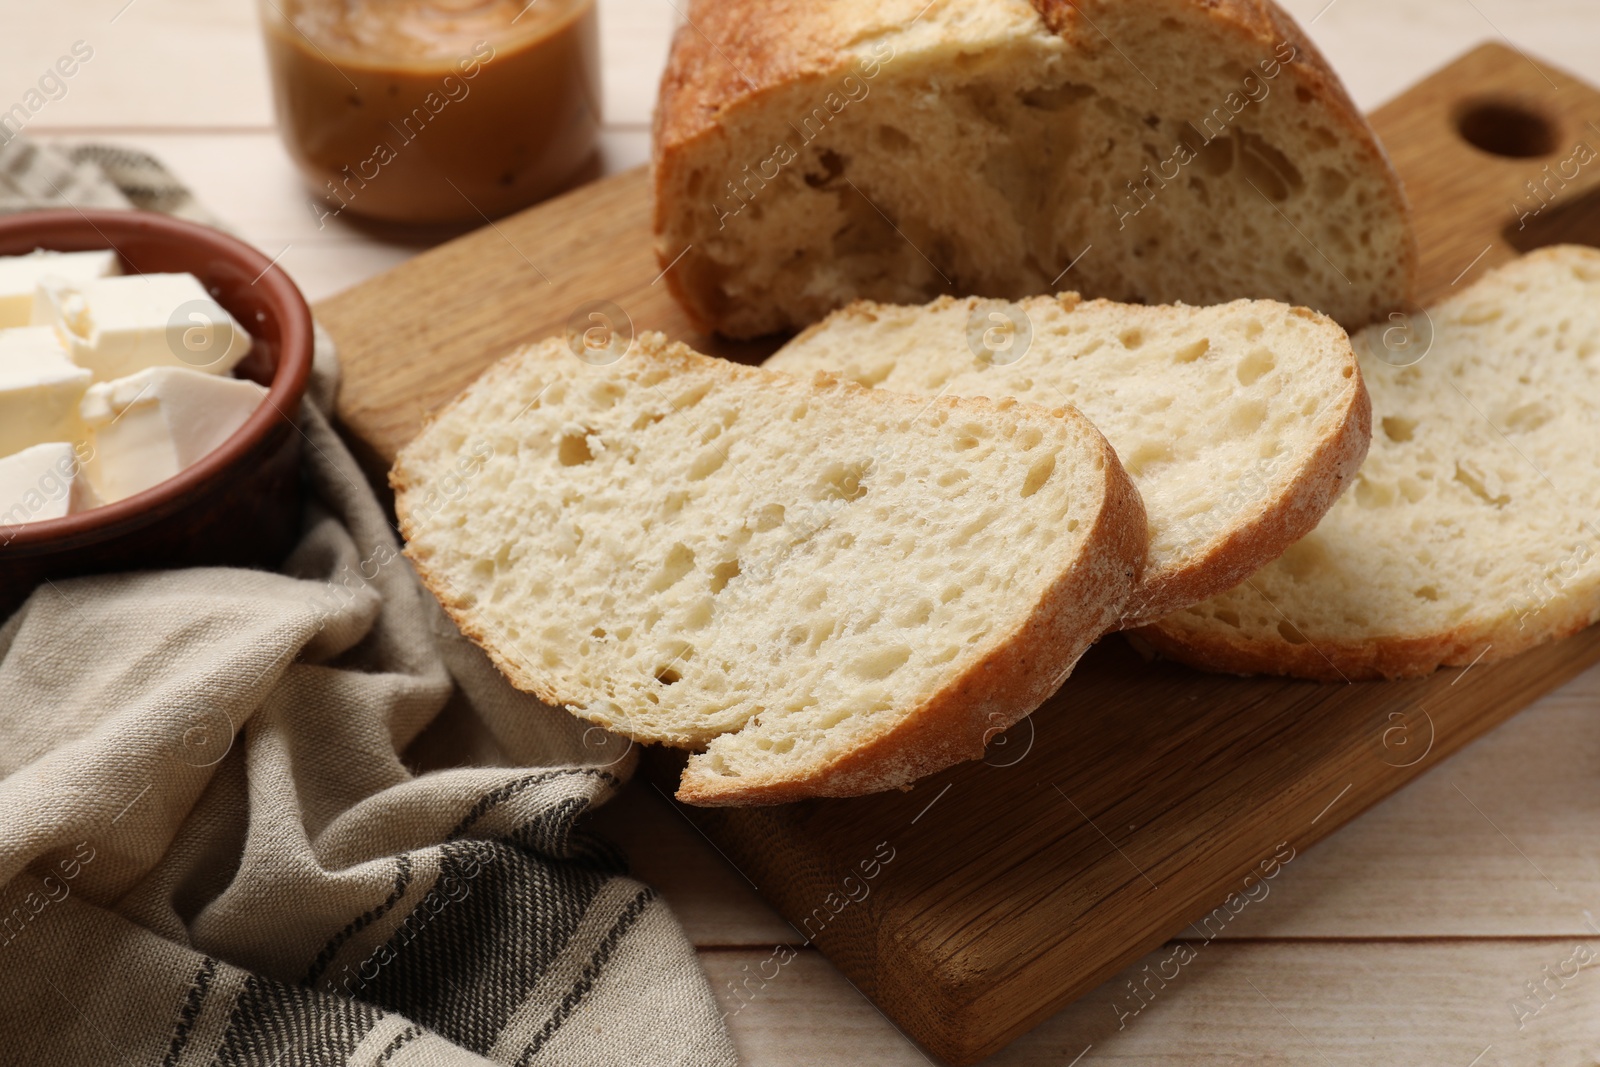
[{"x1": 0, "y1": 141, "x2": 734, "y2": 1067}]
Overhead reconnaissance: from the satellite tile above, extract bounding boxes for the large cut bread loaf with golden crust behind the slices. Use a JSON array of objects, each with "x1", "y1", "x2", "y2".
[{"x1": 653, "y1": 0, "x2": 1416, "y2": 338}]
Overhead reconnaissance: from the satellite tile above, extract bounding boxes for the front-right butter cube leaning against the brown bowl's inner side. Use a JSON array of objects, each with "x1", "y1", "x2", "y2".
[{"x1": 82, "y1": 366, "x2": 267, "y2": 501}]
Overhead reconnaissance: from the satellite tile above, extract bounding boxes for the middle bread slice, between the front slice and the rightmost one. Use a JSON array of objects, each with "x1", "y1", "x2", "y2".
[{"x1": 766, "y1": 293, "x2": 1371, "y2": 627}]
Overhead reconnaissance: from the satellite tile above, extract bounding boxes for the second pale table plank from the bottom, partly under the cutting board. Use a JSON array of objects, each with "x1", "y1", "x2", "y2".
[{"x1": 595, "y1": 670, "x2": 1600, "y2": 953}]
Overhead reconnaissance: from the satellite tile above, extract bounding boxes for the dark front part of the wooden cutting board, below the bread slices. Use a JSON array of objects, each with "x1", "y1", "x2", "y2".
[{"x1": 661, "y1": 629, "x2": 1600, "y2": 1064}]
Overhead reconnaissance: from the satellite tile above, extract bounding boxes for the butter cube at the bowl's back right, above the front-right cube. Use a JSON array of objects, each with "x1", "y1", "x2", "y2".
[{"x1": 34, "y1": 274, "x2": 250, "y2": 382}]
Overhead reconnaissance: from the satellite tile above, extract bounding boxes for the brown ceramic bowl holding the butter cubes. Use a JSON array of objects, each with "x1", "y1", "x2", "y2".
[{"x1": 0, "y1": 210, "x2": 312, "y2": 619}]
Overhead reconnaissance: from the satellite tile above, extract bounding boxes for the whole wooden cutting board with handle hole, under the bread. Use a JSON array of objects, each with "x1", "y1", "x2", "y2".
[{"x1": 317, "y1": 45, "x2": 1600, "y2": 1064}]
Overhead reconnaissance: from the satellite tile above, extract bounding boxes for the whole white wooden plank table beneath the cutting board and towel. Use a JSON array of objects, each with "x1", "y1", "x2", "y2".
[{"x1": 12, "y1": 0, "x2": 1600, "y2": 1067}]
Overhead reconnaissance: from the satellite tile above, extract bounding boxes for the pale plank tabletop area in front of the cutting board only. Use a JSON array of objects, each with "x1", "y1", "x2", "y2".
[{"x1": 597, "y1": 670, "x2": 1600, "y2": 1067}]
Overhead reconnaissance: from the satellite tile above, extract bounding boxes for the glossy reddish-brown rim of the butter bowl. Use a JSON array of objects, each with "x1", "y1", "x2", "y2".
[{"x1": 0, "y1": 208, "x2": 314, "y2": 555}]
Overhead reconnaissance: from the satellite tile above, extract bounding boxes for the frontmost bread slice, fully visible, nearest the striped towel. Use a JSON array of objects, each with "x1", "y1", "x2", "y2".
[{"x1": 400, "y1": 334, "x2": 1146, "y2": 805}]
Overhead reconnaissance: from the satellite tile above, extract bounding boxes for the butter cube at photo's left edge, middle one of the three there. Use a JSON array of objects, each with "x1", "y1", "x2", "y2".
[{"x1": 0, "y1": 326, "x2": 93, "y2": 456}]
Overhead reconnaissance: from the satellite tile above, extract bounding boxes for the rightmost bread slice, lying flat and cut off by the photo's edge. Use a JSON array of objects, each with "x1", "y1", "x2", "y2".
[{"x1": 1142, "y1": 246, "x2": 1600, "y2": 681}]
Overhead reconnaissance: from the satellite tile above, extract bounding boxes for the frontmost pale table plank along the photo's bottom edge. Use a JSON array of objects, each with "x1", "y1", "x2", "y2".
[{"x1": 702, "y1": 934, "x2": 1600, "y2": 1067}]
